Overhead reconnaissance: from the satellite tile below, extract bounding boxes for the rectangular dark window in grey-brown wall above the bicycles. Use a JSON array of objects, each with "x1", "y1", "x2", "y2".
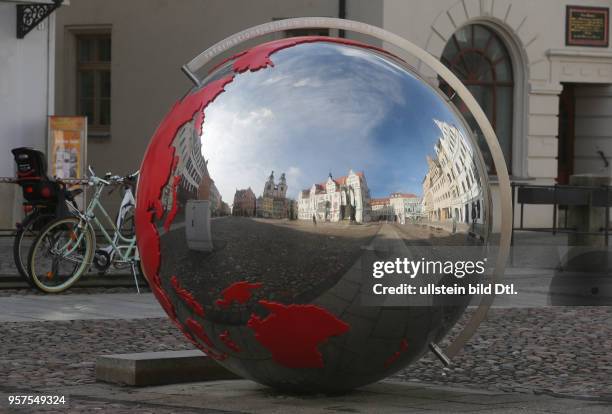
[{"x1": 76, "y1": 33, "x2": 111, "y2": 136}]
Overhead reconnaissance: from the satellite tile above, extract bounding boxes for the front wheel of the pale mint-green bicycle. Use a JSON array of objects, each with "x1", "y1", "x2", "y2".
[{"x1": 29, "y1": 217, "x2": 95, "y2": 293}]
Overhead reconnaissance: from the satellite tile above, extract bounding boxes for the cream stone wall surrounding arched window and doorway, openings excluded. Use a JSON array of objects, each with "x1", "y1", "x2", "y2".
[{"x1": 383, "y1": 0, "x2": 612, "y2": 229}]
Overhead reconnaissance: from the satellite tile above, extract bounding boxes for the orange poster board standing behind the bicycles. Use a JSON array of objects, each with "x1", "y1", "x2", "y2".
[{"x1": 48, "y1": 116, "x2": 87, "y2": 178}]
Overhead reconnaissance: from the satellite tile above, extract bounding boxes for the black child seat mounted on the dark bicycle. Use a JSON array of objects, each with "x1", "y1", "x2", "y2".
[{"x1": 11, "y1": 147, "x2": 61, "y2": 204}]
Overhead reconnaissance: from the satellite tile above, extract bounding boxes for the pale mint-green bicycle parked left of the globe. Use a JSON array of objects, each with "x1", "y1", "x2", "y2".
[{"x1": 28, "y1": 167, "x2": 142, "y2": 293}]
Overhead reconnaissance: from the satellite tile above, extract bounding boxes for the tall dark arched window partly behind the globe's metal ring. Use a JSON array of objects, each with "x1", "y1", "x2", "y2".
[{"x1": 440, "y1": 24, "x2": 514, "y2": 173}]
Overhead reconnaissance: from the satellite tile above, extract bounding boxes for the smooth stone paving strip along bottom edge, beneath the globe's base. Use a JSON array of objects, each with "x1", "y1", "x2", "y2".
[{"x1": 0, "y1": 380, "x2": 612, "y2": 414}]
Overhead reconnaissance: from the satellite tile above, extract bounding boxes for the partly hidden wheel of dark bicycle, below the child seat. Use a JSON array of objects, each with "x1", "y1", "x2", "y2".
[{"x1": 13, "y1": 211, "x2": 55, "y2": 286}]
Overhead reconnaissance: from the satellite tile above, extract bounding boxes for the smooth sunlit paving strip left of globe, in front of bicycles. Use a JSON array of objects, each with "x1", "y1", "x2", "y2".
[{"x1": 0, "y1": 293, "x2": 166, "y2": 322}]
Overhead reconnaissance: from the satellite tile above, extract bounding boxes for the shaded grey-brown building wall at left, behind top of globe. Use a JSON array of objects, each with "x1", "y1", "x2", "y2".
[{"x1": 49, "y1": 0, "x2": 382, "y2": 217}]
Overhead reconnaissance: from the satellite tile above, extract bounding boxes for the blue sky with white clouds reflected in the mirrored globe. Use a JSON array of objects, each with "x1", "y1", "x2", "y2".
[{"x1": 201, "y1": 42, "x2": 474, "y2": 203}]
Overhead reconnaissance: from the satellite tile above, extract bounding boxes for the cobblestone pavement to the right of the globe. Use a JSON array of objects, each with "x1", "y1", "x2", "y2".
[{"x1": 396, "y1": 307, "x2": 612, "y2": 402}]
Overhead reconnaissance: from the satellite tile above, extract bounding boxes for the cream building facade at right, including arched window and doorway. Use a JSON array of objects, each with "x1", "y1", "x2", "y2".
[{"x1": 382, "y1": 0, "x2": 612, "y2": 230}]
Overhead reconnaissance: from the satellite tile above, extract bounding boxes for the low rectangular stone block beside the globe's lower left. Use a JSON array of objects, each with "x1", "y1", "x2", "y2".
[{"x1": 96, "y1": 349, "x2": 239, "y2": 386}]
